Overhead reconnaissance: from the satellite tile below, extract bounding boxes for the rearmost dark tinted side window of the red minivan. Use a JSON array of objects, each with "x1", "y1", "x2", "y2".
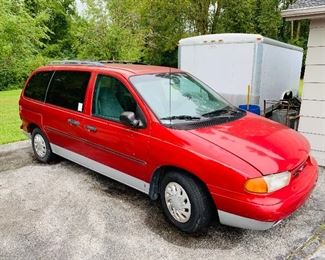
[{"x1": 24, "y1": 71, "x2": 53, "y2": 101}]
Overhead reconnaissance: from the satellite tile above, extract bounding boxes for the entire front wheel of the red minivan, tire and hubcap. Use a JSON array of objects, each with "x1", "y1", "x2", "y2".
[{"x1": 160, "y1": 171, "x2": 212, "y2": 233}]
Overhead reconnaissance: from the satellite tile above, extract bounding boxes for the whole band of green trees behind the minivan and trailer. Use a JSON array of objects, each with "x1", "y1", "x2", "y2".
[{"x1": 0, "y1": 0, "x2": 309, "y2": 89}]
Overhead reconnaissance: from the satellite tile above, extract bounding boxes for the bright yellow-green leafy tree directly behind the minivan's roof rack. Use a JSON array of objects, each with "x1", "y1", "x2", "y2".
[{"x1": 73, "y1": 0, "x2": 144, "y2": 61}]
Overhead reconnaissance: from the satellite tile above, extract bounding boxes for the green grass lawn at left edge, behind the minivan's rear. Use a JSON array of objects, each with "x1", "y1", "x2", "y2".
[{"x1": 0, "y1": 89, "x2": 26, "y2": 144}]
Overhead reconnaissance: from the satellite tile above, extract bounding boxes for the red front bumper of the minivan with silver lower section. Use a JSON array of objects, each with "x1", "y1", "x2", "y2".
[{"x1": 211, "y1": 157, "x2": 318, "y2": 230}]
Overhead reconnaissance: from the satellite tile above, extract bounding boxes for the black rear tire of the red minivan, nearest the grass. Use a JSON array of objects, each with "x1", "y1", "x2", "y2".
[{"x1": 32, "y1": 128, "x2": 54, "y2": 163}]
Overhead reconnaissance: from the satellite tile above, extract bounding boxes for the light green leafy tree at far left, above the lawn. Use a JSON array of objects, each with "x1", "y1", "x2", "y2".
[{"x1": 0, "y1": 0, "x2": 48, "y2": 90}]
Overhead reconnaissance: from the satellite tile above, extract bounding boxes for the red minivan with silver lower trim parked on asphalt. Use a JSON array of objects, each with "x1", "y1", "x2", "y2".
[{"x1": 19, "y1": 61, "x2": 318, "y2": 233}]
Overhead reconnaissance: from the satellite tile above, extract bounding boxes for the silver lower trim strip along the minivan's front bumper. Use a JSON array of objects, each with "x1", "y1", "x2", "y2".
[{"x1": 218, "y1": 210, "x2": 281, "y2": 230}]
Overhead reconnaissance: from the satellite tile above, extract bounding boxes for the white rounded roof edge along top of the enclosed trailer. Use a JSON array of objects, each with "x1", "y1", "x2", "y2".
[{"x1": 179, "y1": 33, "x2": 303, "y2": 51}]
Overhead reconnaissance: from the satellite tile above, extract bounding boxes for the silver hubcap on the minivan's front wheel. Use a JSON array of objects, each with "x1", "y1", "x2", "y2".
[{"x1": 165, "y1": 182, "x2": 191, "y2": 223}]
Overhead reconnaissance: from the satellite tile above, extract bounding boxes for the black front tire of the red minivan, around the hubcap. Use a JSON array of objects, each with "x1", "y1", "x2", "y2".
[{"x1": 159, "y1": 171, "x2": 213, "y2": 233}]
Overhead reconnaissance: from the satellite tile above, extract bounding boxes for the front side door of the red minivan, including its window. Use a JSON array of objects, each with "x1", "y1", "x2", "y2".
[{"x1": 84, "y1": 74, "x2": 150, "y2": 190}]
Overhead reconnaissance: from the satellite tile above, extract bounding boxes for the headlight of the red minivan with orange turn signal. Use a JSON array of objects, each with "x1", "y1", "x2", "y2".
[{"x1": 245, "y1": 172, "x2": 291, "y2": 193}]
